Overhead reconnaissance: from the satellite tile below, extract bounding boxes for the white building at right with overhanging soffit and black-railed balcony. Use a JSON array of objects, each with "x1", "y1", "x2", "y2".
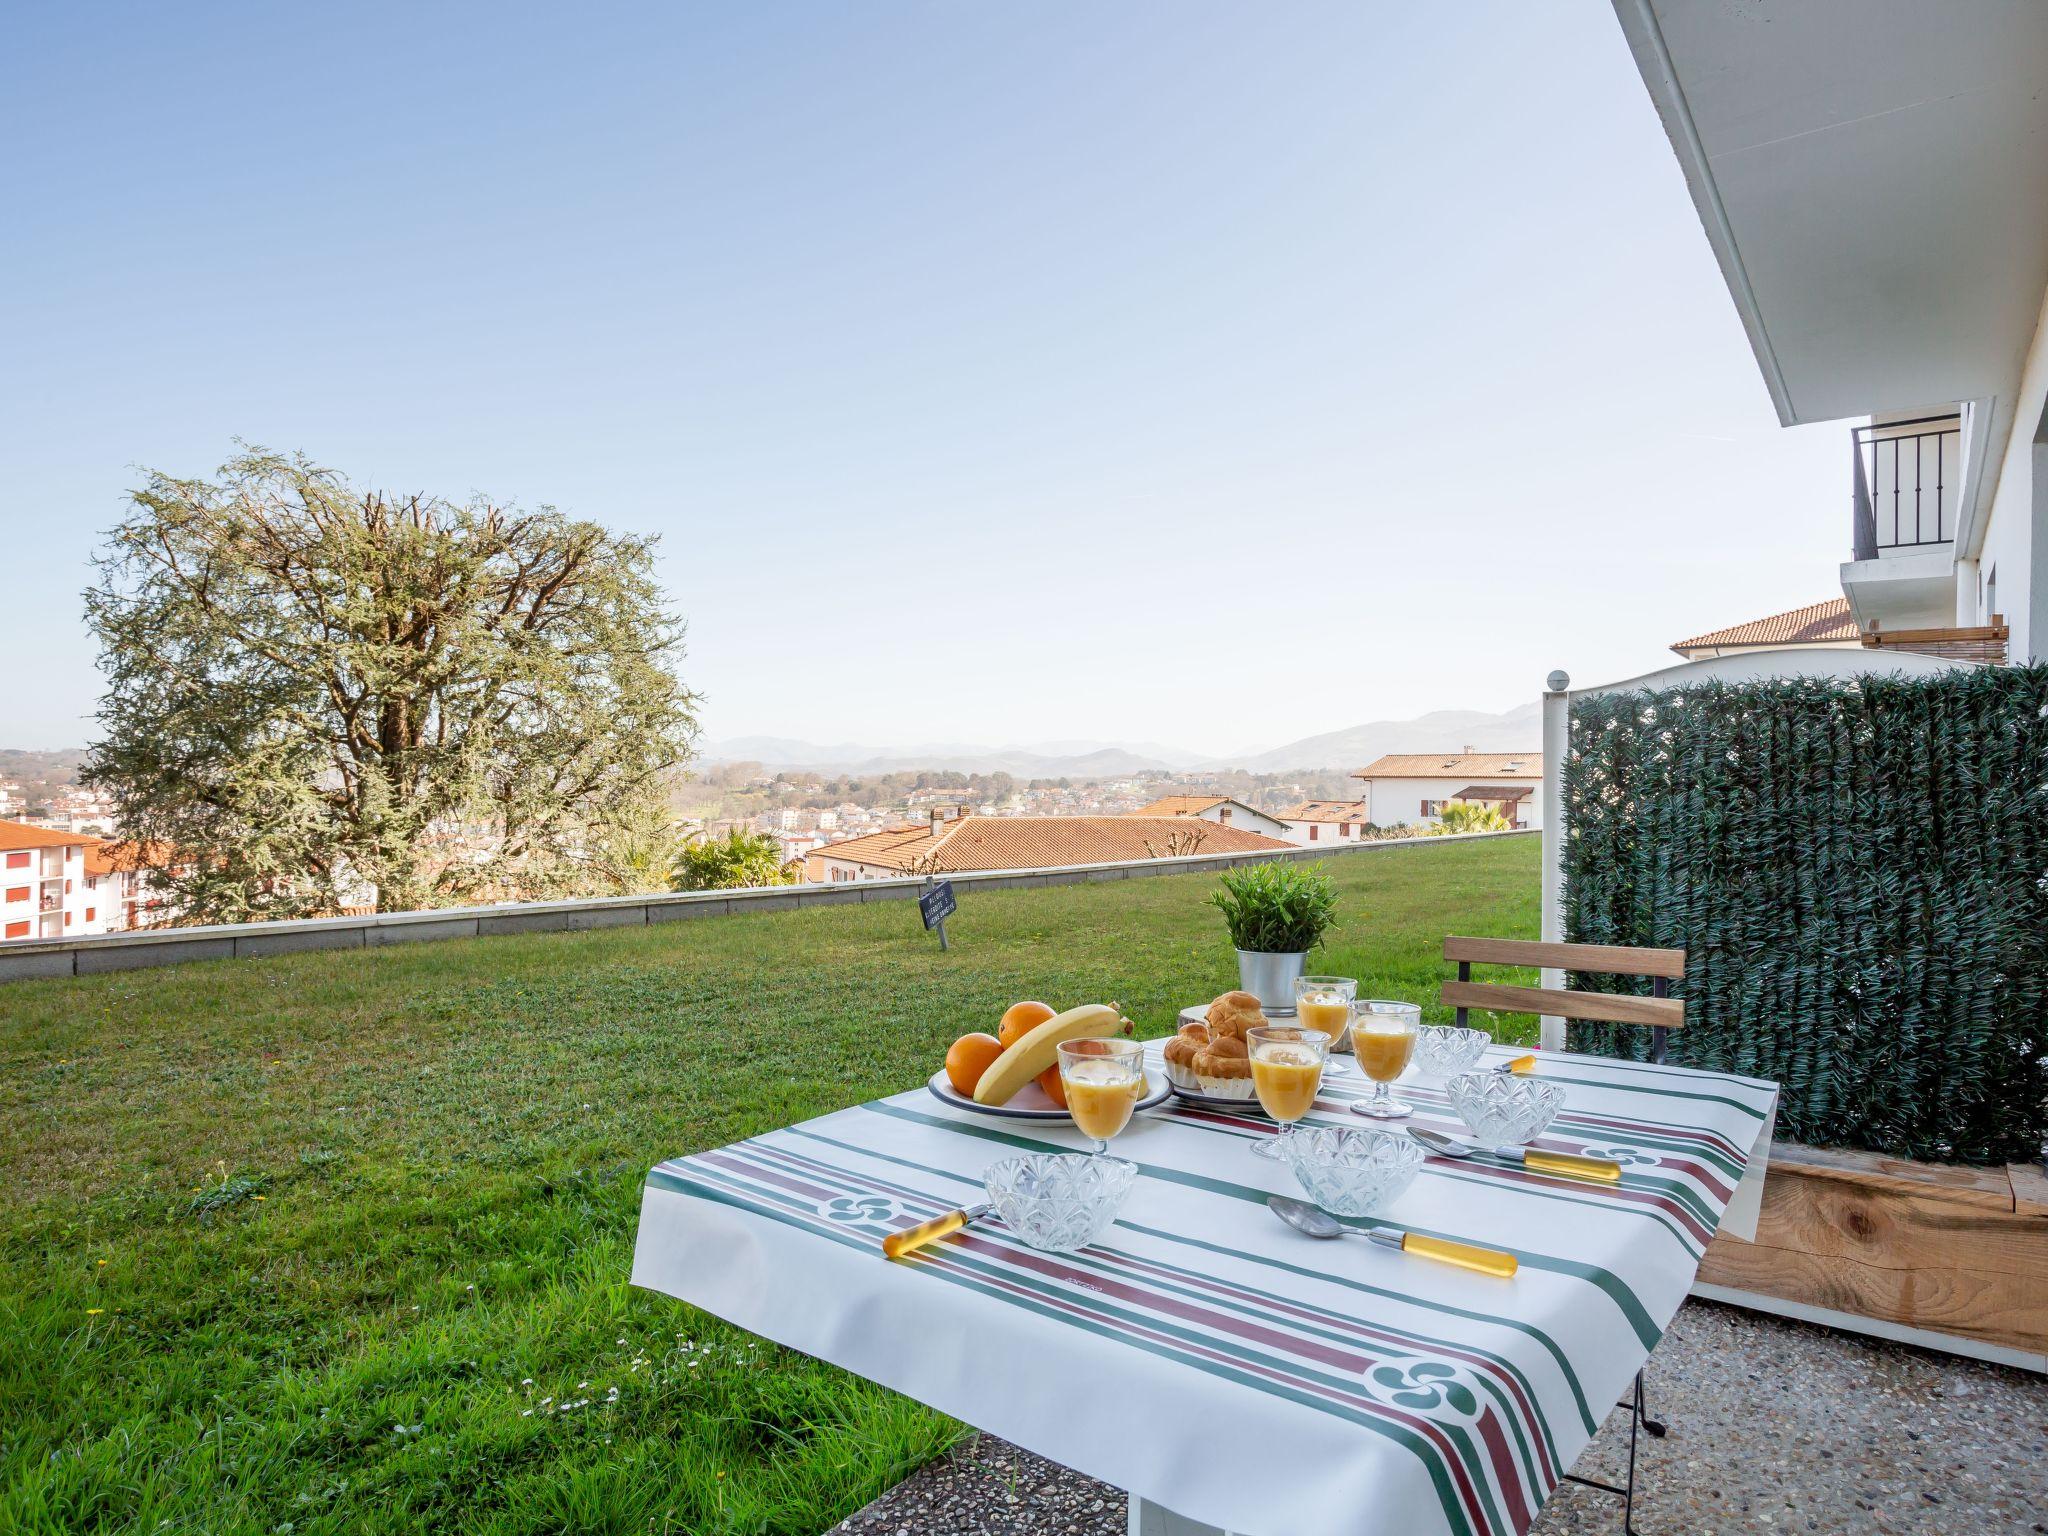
[{"x1": 1616, "y1": 0, "x2": 2048, "y2": 662}]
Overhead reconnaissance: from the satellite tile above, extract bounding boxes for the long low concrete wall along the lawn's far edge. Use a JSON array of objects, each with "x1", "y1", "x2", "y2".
[{"x1": 0, "y1": 831, "x2": 1538, "y2": 981}]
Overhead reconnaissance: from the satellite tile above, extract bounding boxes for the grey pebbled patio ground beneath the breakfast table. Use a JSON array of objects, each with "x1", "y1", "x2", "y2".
[{"x1": 831, "y1": 1303, "x2": 2048, "y2": 1536}]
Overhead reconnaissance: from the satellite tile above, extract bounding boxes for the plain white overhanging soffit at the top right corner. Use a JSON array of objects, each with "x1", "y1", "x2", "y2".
[{"x1": 1614, "y1": 0, "x2": 2048, "y2": 426}]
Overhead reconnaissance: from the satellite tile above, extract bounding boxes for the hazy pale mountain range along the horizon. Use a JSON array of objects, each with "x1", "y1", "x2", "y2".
[{"x1": 702, "y1": 700, "x2": 1542, "y2": 778}]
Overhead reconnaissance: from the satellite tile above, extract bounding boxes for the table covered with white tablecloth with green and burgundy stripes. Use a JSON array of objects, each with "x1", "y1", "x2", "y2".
[{"x1": 633, "y1": 1040, "x2": 1778, "y2": 1536}]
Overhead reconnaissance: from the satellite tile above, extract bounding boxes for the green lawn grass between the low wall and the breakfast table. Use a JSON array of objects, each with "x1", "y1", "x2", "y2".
[{"x1": 0, "y1": 838, "x2": 1538, "y2": 1536}]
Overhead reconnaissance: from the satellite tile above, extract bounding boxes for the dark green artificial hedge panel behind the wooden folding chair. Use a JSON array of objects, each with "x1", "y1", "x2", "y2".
[{"x1": 1563, "y1": 666, "x2": 2048, "y2": 1163}]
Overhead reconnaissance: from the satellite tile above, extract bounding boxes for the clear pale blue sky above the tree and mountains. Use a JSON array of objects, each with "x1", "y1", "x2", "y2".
[{"x1": 0, "y1": 0, "x2": 1847, "y2": 752}]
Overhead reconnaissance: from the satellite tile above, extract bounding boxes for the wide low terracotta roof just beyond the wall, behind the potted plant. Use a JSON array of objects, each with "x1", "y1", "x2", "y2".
[{"x1": 811, "y1": 815, "x2": 1292, "y2": 872}]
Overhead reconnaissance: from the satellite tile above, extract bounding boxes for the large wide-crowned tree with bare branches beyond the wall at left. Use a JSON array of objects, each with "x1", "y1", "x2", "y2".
[{"x1": 84, "y1": 449, "x2": 696, "y2": 922}]
